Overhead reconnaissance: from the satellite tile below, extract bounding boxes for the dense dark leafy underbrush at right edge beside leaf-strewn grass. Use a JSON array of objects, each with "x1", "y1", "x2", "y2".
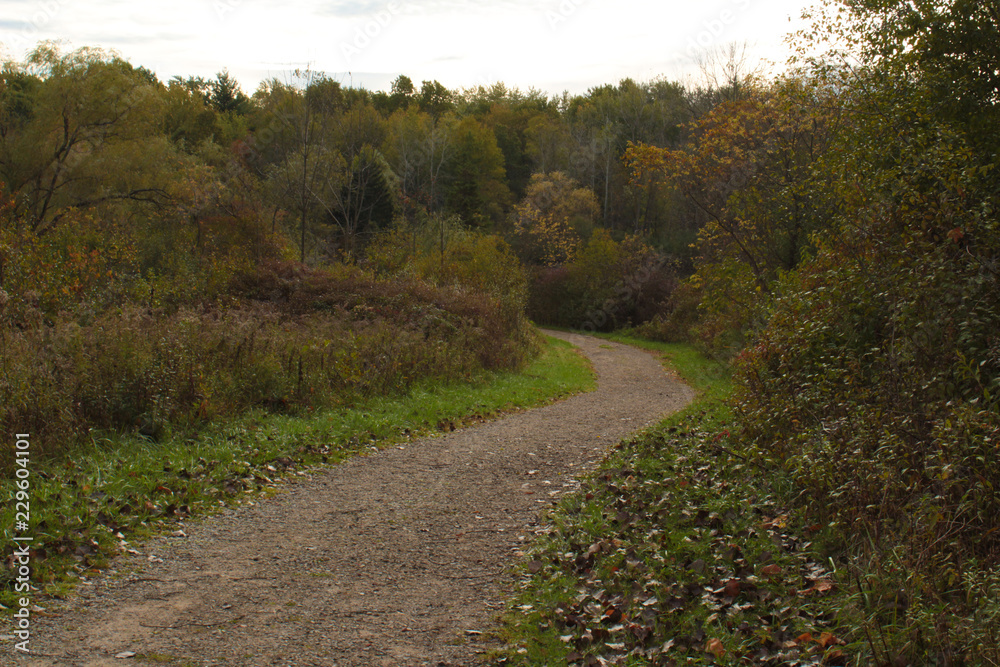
[{"x1": 734, "y1": 237, "x2": 1000, "y2": 665}]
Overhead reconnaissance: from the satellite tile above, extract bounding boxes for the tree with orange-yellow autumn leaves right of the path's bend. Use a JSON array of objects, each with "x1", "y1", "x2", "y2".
[{"x1": 627, "y1": 79, "x2": 837, "y2": 332}]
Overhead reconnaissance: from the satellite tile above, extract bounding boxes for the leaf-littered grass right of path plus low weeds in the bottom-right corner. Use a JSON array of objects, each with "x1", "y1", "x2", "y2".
[{"x1": 500, "y1": 335, "x2": 1000, "y2": 666}]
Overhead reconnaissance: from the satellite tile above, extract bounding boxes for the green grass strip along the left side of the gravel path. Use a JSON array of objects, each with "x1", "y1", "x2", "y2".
[{"x1": 0, "y1": 338, "x2": 596, "y2": 608}]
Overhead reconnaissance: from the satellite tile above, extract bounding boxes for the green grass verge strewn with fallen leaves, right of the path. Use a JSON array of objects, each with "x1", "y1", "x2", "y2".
[{"x1": 495, "y1": 336, "x2": 850, "y2": 665}]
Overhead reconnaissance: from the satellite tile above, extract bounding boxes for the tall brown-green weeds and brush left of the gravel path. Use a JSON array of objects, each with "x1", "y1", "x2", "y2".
[{"x1": 0, "y1": 266, "x2": 537, "y2": 464}]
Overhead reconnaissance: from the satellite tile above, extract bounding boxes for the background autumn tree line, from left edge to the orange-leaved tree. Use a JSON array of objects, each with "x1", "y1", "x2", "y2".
[{"x1": 0, "y1": 44, "x2": 733, "y2": 332}]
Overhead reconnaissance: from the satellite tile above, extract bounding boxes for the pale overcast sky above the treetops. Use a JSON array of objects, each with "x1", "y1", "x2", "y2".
[{"x1": 0, "y1": 0, "x2": 812, "y2": 94}]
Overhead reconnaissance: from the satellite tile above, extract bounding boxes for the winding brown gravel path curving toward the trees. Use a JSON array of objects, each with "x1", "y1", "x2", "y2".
[{"x1": 0, "y1": 332, "x2": 693, "y2": 667}]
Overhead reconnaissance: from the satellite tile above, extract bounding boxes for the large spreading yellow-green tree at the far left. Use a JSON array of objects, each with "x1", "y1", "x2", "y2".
[{"x1": 0, "y1": 44, "x2": 171, "y2": 233}]
